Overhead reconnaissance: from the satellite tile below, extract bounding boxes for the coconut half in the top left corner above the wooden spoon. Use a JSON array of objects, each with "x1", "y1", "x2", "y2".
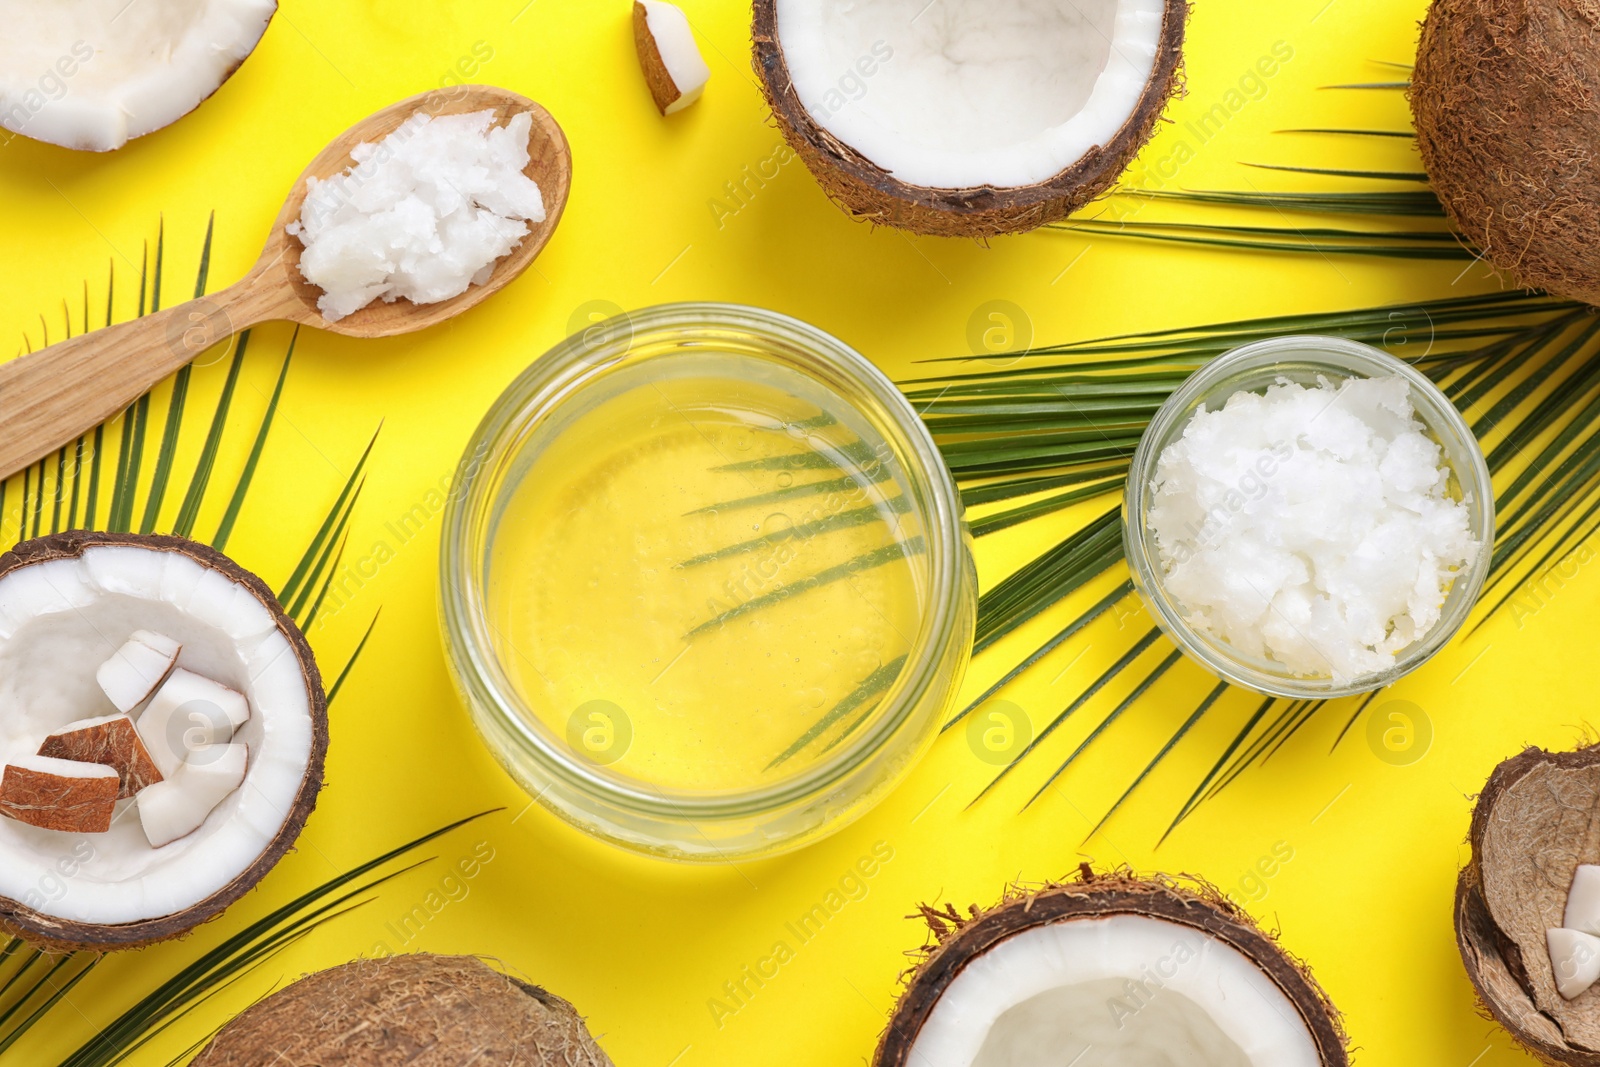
[{"x1": 0, "y1": 0, "x2": 278, "y2": 152}]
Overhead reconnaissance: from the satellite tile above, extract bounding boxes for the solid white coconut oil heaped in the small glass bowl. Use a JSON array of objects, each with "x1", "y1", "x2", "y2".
[{"x1": 1149, "y1": 376, "x2": 1482, "y2": 681}]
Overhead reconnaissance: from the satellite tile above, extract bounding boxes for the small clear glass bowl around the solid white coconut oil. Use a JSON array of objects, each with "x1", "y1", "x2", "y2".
[{"x1": 1122, "y1": 336, "x2": 1494, "y2": 699}]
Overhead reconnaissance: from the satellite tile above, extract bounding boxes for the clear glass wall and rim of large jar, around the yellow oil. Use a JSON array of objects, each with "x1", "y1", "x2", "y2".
[{"x1": 440, "y1": 304, "x2": 978, "y2": 861}]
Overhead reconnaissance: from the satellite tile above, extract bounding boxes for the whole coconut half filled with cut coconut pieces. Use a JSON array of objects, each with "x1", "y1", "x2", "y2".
[{"x1": 0, "y1": 531, "x2": 328, "y2": 950}]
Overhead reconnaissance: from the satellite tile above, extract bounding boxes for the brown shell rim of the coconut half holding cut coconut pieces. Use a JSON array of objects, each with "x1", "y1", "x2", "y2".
[{"x1": 0, "y1": 530, "x2": 328, "y2": 952}]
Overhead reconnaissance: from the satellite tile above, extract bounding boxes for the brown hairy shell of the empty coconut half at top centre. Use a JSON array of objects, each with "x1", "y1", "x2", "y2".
[{"x1": 752, "y1": 0, "x2": 1189, "y2": 238}]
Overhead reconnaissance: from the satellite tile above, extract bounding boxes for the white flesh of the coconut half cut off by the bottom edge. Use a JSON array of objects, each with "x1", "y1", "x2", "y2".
[{"x1": 907, "y1": 915, "x2": 1322, "y2": 1067}]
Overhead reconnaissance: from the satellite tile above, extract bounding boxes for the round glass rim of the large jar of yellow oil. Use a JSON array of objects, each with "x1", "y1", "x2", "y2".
[{"x1": 440, "y1": 302, "x2": 965, "y2": 821}]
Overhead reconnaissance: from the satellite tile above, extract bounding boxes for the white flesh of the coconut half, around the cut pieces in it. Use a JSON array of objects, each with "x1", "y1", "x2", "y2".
[{"x1": 0, "y1": 545, "x2": 314, "y2": 925}]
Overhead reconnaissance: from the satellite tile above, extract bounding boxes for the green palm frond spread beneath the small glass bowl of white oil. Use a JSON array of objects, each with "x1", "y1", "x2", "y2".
[{"x1": 921, "y1": 293, "x2": 1600, "y2": 833}]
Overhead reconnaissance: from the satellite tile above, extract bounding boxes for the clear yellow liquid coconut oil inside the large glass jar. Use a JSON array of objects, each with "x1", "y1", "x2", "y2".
[{"x1": 485, "y1": 350, "x2": 928, "y2": 793}]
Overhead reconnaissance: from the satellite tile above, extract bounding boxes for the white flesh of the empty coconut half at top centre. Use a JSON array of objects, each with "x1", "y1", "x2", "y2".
[{"x1": 776, "y1": 0, "x2": 1165, "y2": 189}]
